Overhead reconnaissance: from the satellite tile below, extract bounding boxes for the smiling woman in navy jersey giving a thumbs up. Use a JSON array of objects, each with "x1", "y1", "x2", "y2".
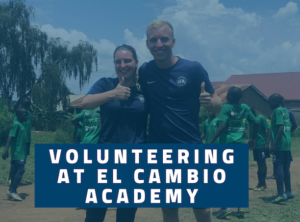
[{"x1": 81, "y1": 44, "x2": 148, "y2": 222}]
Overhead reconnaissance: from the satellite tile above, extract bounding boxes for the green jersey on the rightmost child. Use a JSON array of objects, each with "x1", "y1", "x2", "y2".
[{"x1": 271, "y1": 107, "x2": 291, "y2": 151}]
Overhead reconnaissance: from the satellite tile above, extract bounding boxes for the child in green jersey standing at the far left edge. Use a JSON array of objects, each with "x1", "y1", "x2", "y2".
[{"x1": 2, "y1": 108, "x2": 28, "y2": 201}]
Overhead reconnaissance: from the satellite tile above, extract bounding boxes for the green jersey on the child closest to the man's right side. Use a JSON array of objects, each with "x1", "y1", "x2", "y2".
[{"x1": 219, "y1": 104, "x2": 258, "y2": 143}]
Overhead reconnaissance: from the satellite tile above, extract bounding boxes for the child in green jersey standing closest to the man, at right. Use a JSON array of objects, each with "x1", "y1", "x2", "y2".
[{"x1": 210, "y1": 86, "x2": 258, "y2": 219}]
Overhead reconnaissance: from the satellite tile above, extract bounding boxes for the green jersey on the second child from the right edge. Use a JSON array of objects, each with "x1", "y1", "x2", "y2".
[{"x1": 250, "y1": 115, "x2": 270, "y2": 149}]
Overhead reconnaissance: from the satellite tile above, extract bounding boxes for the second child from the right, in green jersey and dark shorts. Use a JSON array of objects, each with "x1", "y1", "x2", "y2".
[{"x1": 250, "y1": 108, "x2": 270, "y2": 191}]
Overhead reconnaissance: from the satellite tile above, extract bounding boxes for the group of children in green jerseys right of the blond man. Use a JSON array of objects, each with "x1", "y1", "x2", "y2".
[{"x1": 201, "y1": 87, "x2": 297, "y2": 219}]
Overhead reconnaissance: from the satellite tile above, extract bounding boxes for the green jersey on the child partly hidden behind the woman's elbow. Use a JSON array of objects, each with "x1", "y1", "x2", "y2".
[{"x1": 76, "y1": 107, "x2": 100, "y2": 144}]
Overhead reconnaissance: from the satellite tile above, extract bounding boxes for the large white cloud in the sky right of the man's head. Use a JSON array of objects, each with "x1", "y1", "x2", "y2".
[{"x1": 123, "y1": 0, "x2": 300, "y2": 81}]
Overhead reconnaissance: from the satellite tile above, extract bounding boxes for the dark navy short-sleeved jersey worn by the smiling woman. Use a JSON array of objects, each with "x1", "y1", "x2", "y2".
[{"x1": 87, "y1": 78, "x2": 148, "y2": 143}]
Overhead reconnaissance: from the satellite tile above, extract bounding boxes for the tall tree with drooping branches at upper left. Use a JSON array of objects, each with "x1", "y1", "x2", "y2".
[{"x1": 0, "y1": 0, "x2": 97, "y2": 112}]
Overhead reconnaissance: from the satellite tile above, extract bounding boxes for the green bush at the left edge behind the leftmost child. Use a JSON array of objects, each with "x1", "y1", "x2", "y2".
[{"x1": 0, "y1": 99, "x2": 13, "y2": 146}]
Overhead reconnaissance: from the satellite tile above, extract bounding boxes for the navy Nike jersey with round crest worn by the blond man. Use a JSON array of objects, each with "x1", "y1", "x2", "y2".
[{"x1": 139, "y1": 58, "x2": 214, "y2": 143}]
